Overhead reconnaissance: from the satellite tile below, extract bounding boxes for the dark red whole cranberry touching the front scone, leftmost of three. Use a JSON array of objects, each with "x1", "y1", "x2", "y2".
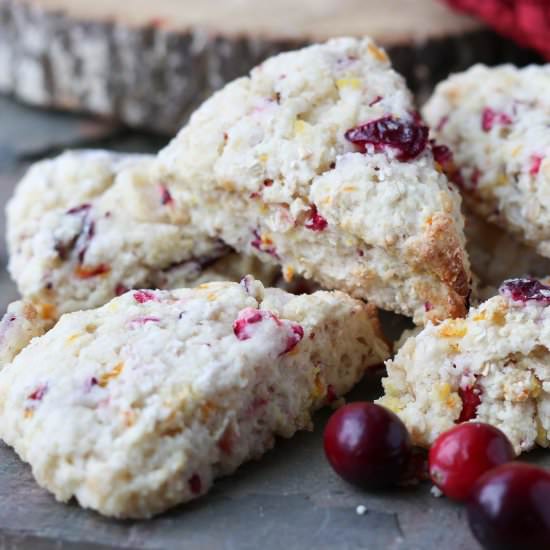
[{"x1": 324, "y1": 402, "x2": 411, "y2": 489}]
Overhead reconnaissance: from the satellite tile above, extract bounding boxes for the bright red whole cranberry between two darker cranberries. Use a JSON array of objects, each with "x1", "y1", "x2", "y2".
[{"x1": 429, "y1": 422, "x2": 515, "y2": 500}]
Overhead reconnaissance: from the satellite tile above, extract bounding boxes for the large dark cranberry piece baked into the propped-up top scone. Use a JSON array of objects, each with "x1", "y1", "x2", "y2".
[{"x1": 345, "y1": 116, "x2": 429, "y2": 162}]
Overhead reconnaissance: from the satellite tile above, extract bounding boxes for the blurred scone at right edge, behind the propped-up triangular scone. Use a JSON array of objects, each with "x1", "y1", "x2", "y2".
[{"x1": 424, "y1": 65, "x2": 550, "y2": 257}]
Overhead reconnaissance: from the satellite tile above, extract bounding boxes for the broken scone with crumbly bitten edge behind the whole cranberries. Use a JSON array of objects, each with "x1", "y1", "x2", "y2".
[{"x1": 378, "y1": 279, "x2": 550, "y2": 453}]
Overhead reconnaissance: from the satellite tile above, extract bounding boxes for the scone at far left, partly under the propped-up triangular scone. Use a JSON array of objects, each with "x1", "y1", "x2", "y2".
[{"x1": 7, "y1": 151, "x2": 282, "y2": 316}]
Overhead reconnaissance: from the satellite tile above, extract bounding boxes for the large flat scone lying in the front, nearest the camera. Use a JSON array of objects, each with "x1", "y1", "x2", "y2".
[{"x1": 0, "y1": 277, "x2": 389, "y2": 518}]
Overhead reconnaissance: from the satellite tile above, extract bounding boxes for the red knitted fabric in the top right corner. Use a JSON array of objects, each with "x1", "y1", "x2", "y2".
[{"x1": 444, "y1": 0, "x2": 550, "y2": 60}]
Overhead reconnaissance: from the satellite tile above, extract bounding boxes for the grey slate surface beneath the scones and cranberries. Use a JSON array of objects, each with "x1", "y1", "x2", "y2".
[{"x1": 0, "y1": 99, "x2": 550, "y2": 550}]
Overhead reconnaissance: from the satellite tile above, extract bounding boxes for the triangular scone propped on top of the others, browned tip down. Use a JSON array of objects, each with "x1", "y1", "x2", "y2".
[{"x1": 157, "y1": 38, "x2": 470, "y2": 322}]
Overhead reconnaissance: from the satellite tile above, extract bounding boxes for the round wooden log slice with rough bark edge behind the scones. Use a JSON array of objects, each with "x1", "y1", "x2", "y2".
[{"x1": 0, "y1": 0, "x2": 544, "y2": 134}]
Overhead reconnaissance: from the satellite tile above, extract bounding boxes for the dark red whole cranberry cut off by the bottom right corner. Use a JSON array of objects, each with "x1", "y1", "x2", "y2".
[{"x1": 467, "y1": 462, "x2": 550, "y2": 550}]
